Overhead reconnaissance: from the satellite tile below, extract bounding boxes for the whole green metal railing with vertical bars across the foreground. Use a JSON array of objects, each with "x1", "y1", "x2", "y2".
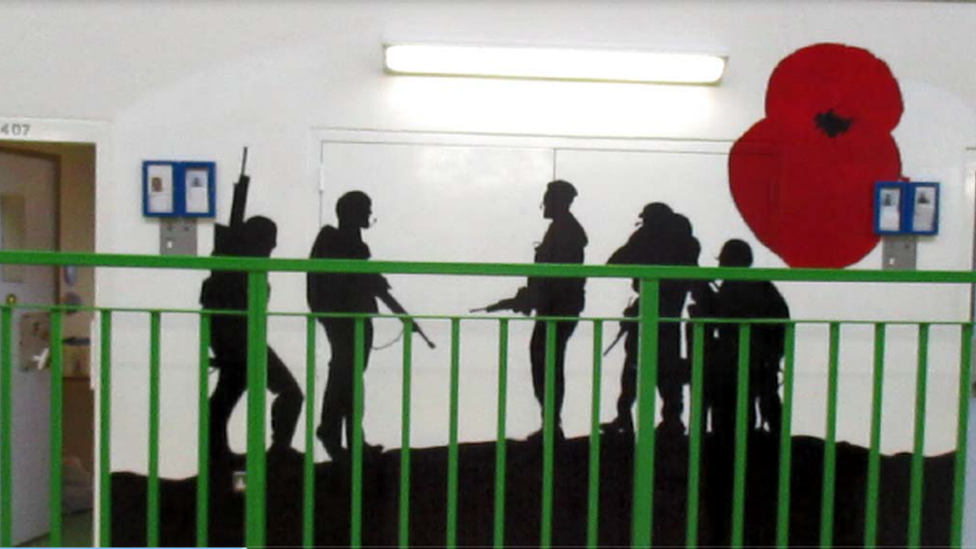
[{"x1": 0, "y1": 252, "x2": 976, "y2": 547}]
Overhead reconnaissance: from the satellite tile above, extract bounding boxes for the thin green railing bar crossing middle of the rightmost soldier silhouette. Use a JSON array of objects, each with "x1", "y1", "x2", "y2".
[{"x1": 732, "y1": 324, "x2": 753, "y2": 547}]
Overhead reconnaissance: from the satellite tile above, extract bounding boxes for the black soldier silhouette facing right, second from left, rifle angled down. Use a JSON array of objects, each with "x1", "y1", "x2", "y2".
[{"x1": 306, "y1": 191, "x2": 434, "y2": 460}]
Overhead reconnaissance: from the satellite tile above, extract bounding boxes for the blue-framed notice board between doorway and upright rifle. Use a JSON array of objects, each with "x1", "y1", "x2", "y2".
[{"x1": 142, "y1": 160, "x2": 217, "y2": 217}]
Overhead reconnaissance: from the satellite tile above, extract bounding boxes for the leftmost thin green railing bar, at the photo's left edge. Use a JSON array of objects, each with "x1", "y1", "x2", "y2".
[{"x1": 0, "y1": 305, "x2": 14, "y2": 547}]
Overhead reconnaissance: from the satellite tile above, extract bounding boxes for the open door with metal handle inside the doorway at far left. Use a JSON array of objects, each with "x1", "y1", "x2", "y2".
[{"x1": 0, "y1": 150, "x2": 58, "y2": 544}]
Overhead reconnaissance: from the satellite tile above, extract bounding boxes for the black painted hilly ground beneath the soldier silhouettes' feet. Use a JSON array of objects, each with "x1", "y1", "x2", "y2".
[{"x1": 112, "y1": 435, "x2": 954, "y2": 547}]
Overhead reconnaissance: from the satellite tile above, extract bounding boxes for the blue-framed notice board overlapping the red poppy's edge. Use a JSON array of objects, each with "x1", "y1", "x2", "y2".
[{"x1": 874, "y1": 181, "x2": 939, "y2": 235}]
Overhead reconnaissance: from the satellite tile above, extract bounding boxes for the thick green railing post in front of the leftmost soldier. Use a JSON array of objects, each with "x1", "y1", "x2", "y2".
[{"x1": 245, "y1": 271, "x2": 268, "y2": 547}]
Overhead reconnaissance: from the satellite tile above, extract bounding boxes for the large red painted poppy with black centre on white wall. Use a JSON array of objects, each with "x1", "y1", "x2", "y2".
[{"x1": 729, "y1": 44, "x2": 903, "y2": 268}]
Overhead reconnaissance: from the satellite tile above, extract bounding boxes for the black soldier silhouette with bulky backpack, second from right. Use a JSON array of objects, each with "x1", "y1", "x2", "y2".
[{"x1": 605, "y1": 202, "x2": 701, "y2": 434}]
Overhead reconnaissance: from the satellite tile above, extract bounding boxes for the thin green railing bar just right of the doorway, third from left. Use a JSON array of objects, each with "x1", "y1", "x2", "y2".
[{"x1": 98, "y1": 311, "x2": 112, "y2": 547}]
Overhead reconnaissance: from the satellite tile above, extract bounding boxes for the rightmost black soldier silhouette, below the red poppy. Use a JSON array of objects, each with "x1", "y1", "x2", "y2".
[{"x1": 699, "y1": 239, "x2": 790, "y2": 445}]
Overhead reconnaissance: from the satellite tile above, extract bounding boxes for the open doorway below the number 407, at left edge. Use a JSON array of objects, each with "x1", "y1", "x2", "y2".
[{"x1": 0, "y1": 141, "x2": 96, "y2": 546}]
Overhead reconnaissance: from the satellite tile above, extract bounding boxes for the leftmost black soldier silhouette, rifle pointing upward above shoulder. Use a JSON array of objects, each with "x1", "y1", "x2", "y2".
[{"x1": 200, "y1": 148, "x2": 303, "y2": 462}]
